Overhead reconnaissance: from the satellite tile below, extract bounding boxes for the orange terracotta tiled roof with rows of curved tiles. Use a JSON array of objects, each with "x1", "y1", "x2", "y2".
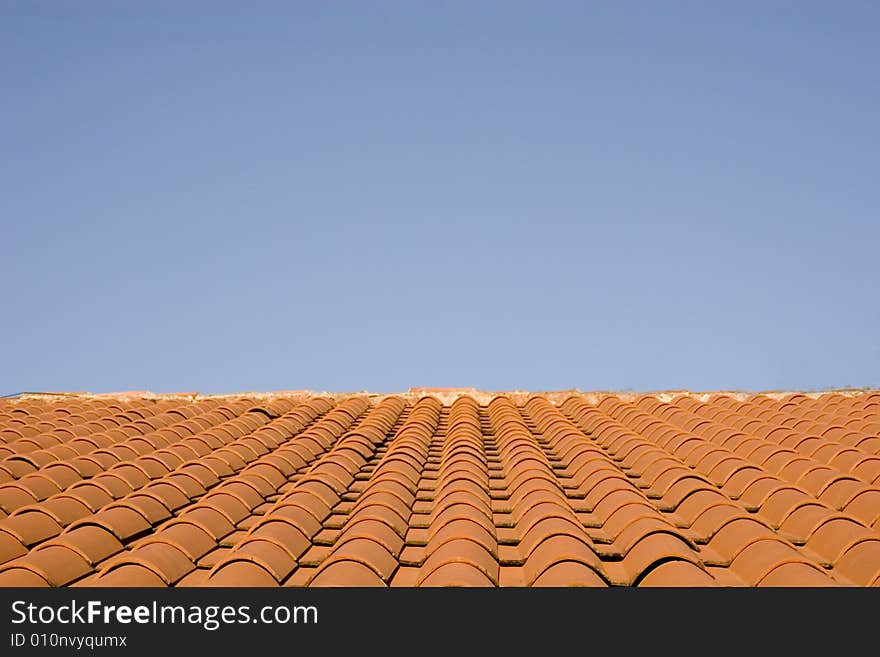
[{"x1": 0, "y1": 388, "x2": 880, "y2": 586}]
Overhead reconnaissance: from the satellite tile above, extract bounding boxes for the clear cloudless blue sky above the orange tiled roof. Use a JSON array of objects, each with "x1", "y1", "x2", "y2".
[{"x1": 0, "y1": 0, "x2": 880, "y2": 393}]
